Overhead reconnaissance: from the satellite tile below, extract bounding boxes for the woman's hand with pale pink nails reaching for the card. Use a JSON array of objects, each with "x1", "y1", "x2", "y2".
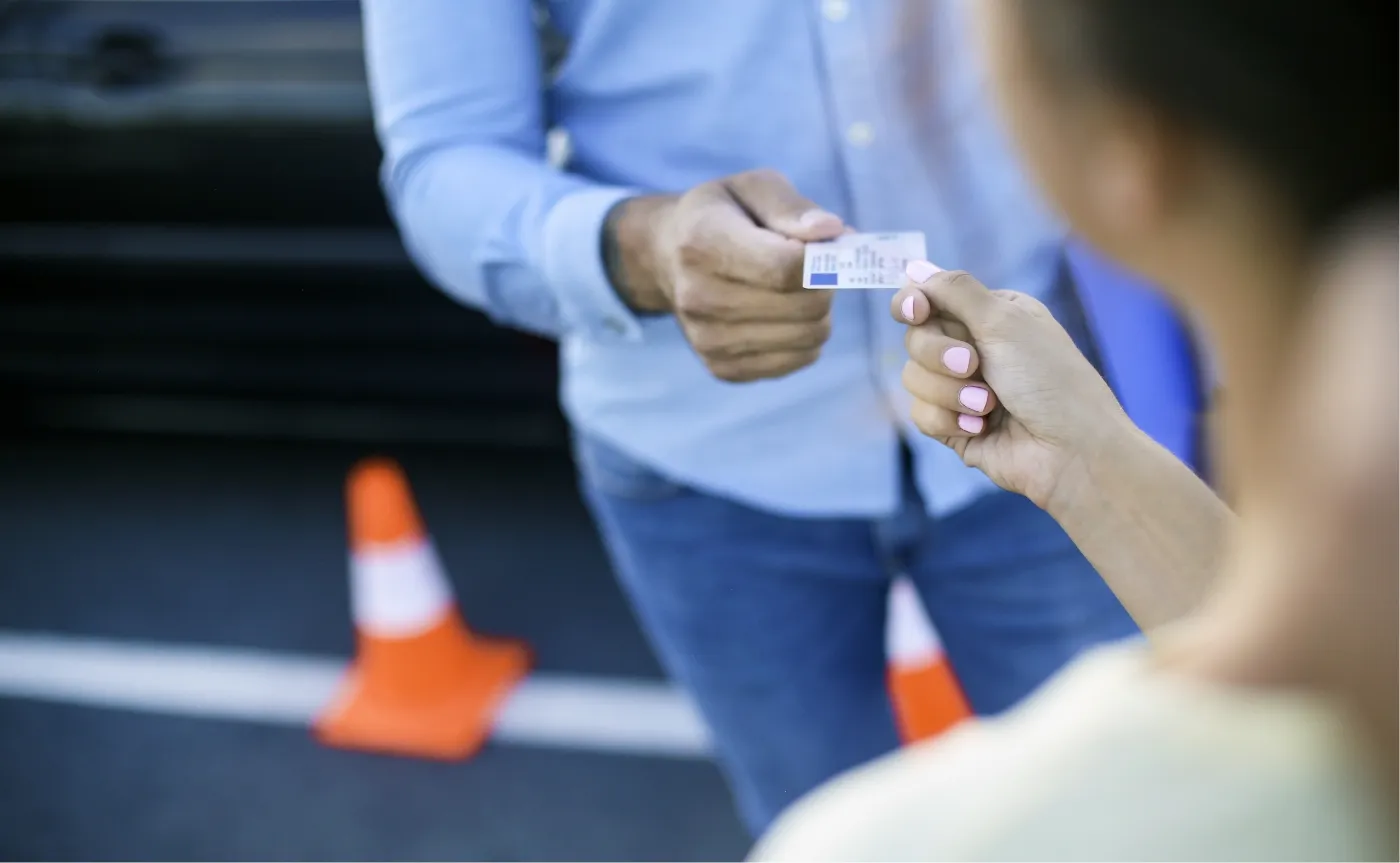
[{"x1": 890, "y1": 261, "x2": 1131, "y2": 509}]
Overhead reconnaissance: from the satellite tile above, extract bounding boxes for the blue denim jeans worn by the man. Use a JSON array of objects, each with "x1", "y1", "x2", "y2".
[{"x1": 575, "y1": 436, "x2": 1137, "y2": 835}]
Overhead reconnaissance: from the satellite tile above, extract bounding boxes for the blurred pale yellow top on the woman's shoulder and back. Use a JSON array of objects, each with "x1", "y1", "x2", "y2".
[{"x1": 753, "y1": 643, "x2": 1396, "y2": 862}]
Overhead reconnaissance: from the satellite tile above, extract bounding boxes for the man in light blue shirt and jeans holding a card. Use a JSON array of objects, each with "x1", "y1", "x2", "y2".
[{"x1": 364, "y1": 0, "x2": 1133, "y2": 831}]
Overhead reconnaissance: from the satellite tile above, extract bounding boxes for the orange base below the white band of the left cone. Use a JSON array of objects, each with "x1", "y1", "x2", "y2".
[{"x1": 316, "y1": 614, "x2": 531, "y2": 761}]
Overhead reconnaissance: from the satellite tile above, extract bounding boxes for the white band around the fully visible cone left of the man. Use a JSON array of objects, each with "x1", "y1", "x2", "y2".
[{"x1": 350, "y1": 541, "x2": 452, "y2": 639}]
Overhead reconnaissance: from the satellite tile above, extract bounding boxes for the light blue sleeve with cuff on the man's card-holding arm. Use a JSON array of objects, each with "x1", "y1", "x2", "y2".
[{"x1": 361, "y1": 0, "x2": 641, "y2": 340}]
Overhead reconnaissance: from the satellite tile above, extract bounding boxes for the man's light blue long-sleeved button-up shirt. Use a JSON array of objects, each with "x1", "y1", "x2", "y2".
[{"x1": 364, "y1": 0, "x2": 1063, "y2": 516}]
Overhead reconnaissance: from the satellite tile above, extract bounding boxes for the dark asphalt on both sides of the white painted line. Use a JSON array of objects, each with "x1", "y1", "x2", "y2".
[{"x1": 0, "y1": 436, "x2": 748, "y2": 860}]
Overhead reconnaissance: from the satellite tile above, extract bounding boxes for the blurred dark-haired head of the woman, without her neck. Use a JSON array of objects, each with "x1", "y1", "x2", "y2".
[{"x1": 979, "y1": 0, "x2": 1396, "y2": 300}]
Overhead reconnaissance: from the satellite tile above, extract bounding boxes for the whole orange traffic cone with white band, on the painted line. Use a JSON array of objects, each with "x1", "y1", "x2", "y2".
[{"x1": 315, "y1": 460, "x2": 531, "y2": 759}]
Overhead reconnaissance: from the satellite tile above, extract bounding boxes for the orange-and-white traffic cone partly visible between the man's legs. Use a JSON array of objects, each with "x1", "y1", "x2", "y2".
[{"x1": 885, "y1": 577, "x2": 972, "y2": 743}]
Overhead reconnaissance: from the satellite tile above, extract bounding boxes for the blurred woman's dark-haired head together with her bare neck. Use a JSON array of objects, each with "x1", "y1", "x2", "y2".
[{"x1": 979, "y1": 0, "x2": 1397, "y2": 782}]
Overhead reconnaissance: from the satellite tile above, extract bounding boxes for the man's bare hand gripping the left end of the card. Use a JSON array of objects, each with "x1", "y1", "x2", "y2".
[{"x1": 606, "y1": 171, "x2": 844, "y2": 382}]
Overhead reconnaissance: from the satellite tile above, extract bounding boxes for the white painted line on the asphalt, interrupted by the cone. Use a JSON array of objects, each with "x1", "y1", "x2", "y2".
[{"x1": 0, "y1": 630, "x2": 710, "y2": 758}]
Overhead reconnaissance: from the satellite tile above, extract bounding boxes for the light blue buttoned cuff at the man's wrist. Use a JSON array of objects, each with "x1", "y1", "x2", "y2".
[{"x1": 543, "y1": 186, "x2": 641, "y2": 342}]
